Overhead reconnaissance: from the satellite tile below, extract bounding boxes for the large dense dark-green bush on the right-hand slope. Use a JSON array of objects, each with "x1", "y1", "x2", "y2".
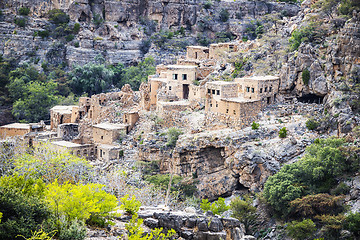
[{"x1": 263, "y1": 138, "x2": 359, "y2": 215}]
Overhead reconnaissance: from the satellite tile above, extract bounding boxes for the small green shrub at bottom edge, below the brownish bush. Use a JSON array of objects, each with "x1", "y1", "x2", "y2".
[{"x1": 286, "y1": 219, "x2": 316, "y2": 240}]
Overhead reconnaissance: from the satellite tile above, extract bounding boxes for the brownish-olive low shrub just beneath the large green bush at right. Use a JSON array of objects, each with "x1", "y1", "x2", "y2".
[{"x1": 290, "y1": 193, "x2": 343, "y2": 217}]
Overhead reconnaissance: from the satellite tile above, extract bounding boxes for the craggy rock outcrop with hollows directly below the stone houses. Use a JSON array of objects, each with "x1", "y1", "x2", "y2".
[{"x1": 139, "y1": 106, "x2": 323, "y2": 200}]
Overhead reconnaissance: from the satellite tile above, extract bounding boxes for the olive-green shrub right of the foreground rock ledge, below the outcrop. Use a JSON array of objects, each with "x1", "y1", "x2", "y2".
[{"x1": 230, "y1": 197, "x2": 258, "y2": 232}]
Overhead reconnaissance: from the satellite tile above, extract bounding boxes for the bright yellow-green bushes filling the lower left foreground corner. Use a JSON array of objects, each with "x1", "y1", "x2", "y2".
[{"x1": 0, "y1": 146, "x2": 118, "y2": 240}]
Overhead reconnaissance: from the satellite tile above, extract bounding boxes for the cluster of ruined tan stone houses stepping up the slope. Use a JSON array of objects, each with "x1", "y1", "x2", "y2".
[{"x1": 0, "y1": 42, "x2": 279, "y2": 161}]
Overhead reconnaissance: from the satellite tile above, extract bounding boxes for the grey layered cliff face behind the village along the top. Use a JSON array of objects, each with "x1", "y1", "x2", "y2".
[{"x1": 0, "y1": 0, "x2": 299, "y2": 66}]
